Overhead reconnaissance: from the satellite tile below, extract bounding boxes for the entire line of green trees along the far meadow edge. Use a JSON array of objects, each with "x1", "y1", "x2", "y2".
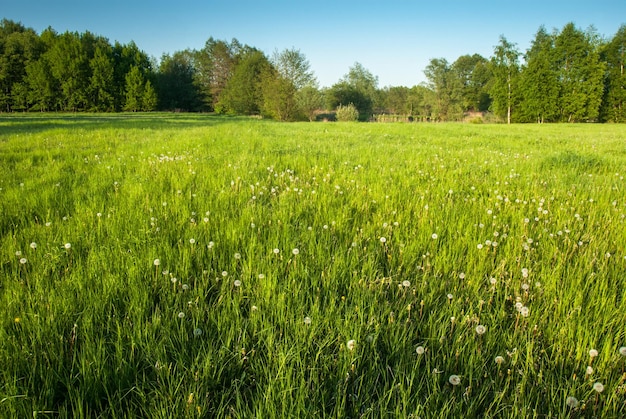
[{"x1": 0, "y1": 19, "x2": 626, "y2": 123}]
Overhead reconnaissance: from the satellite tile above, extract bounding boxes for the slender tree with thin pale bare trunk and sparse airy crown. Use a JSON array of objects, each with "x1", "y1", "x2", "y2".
[{"x1": 490, "y1": 36, "x2": 520, "y2": 124}]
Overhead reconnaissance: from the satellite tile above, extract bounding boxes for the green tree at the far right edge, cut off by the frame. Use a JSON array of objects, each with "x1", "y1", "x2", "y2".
[{"x1": 602, "y1": 25, "x2": 626, "y2": 122}]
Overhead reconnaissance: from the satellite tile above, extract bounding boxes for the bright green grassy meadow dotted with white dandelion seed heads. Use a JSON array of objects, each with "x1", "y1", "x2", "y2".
[{"x1": 0, "y1": 115, "x2": 626, "y2": 418}]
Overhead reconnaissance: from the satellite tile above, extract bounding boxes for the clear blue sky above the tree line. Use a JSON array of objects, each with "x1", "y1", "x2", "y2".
[{"x1": 0, "y1": 0, "x2": 626, "y2": 87}]
